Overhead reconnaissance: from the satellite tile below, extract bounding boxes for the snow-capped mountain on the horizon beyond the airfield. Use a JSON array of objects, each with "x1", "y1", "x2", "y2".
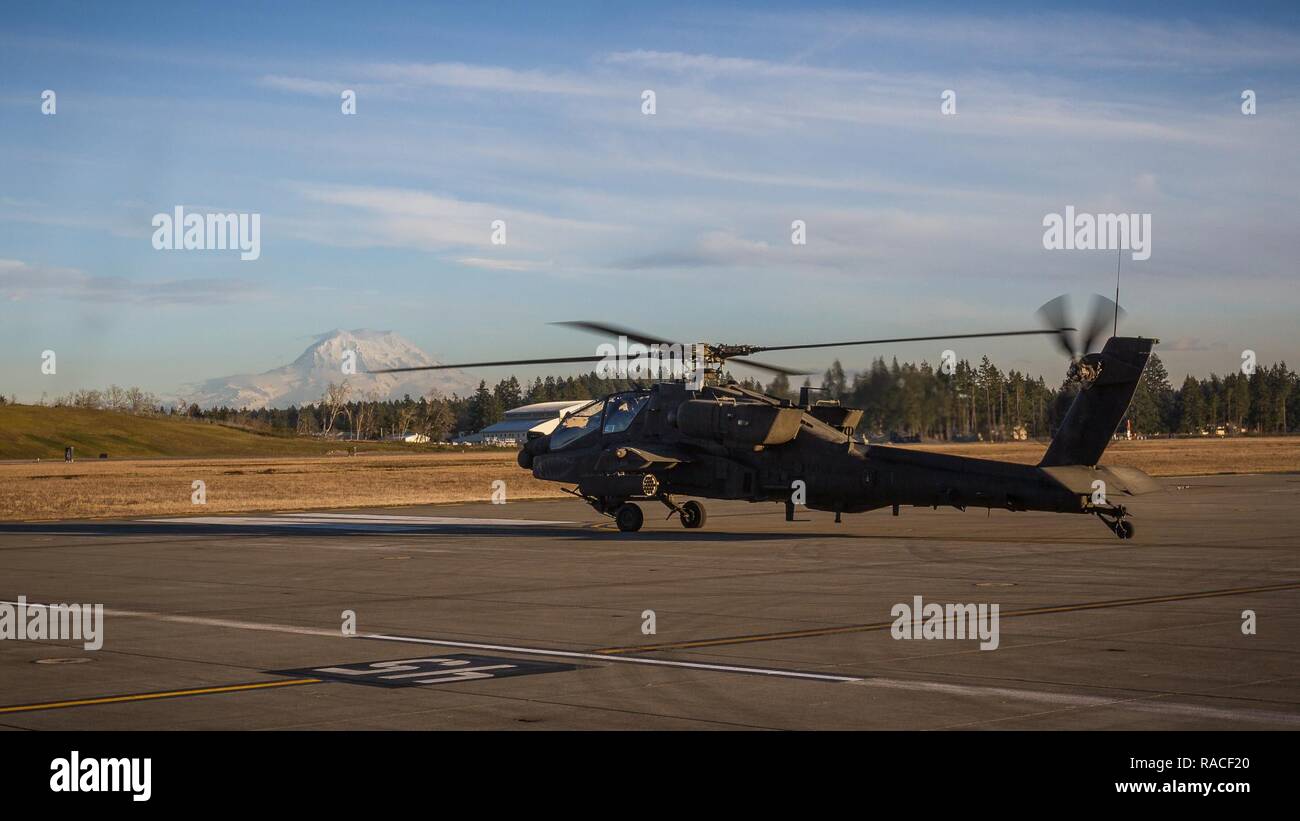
[{"x1": 179, "y1": 329, "x2": 478, "y2": 408}]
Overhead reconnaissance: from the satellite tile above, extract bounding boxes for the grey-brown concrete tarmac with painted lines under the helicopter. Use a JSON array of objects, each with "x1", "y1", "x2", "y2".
[{"x1": 0, "y1": 475, "x2": 1300, "y2": 730}]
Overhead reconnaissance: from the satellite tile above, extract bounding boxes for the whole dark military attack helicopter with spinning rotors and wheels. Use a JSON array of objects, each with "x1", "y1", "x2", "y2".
[{"x1": 373, "y1": 296, "x2": 1160, "y2": 539}]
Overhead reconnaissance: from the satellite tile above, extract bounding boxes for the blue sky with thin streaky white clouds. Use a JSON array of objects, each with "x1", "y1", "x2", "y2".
[{"x1": 0, "y1": 3, "x2": 1300, "y2": 400}]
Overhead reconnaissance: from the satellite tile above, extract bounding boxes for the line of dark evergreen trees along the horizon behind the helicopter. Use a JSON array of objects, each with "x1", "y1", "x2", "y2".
[{"x1": 20, "y1": 355, "x2": 1300, "y2": 442}]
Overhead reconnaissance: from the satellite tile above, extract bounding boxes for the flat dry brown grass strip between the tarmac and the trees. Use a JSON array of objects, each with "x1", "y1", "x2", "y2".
[{"x1": 0, "y1": 436, "x2": 1300, "y2": 521}]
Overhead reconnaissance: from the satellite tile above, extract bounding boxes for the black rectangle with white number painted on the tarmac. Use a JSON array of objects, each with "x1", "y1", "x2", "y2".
[{"x1": 274, "y1": 653, "x2": 581, "y2": 687}]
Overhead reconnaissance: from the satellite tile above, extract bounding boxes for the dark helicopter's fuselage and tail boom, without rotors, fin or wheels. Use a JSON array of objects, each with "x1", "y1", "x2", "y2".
[{"x1": 520, "y1": 382, "x2": 1154, "y2": 522}]
